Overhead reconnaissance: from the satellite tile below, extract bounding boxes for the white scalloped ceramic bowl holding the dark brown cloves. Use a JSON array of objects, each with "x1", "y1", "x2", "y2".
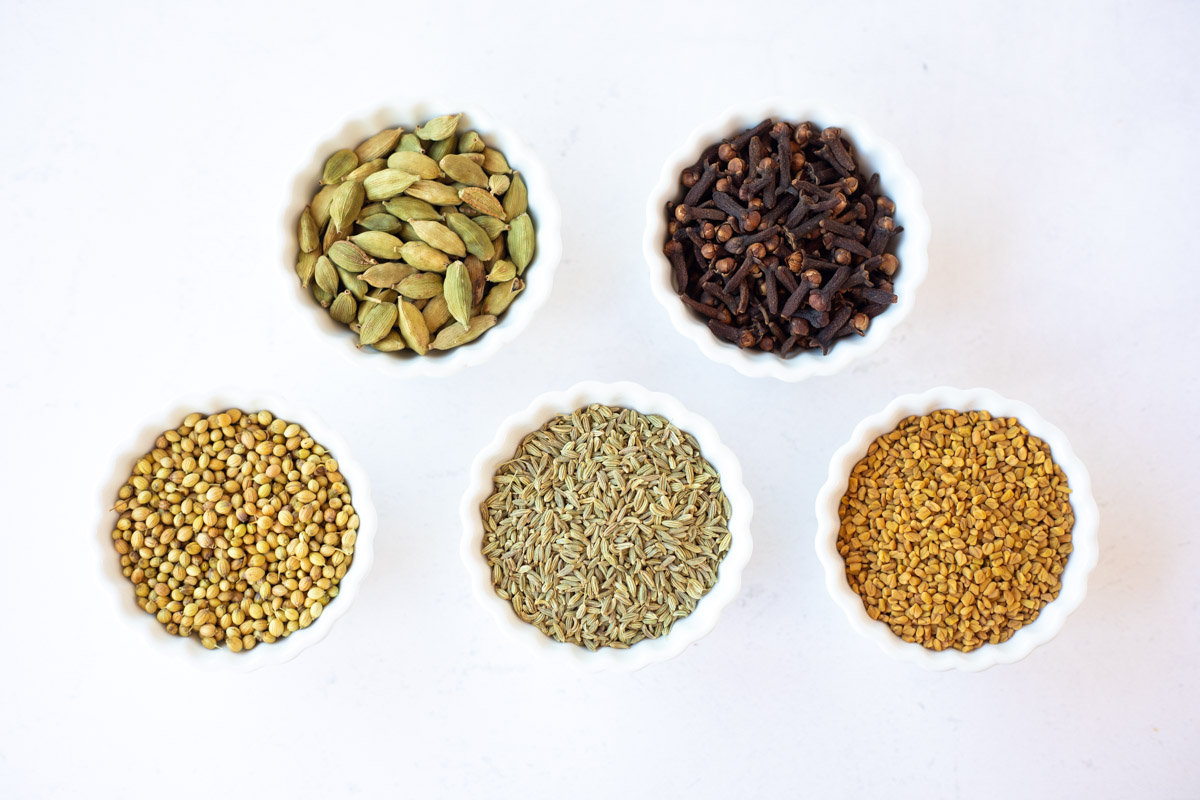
[{"x1": 642, "y1": 100, "x2": 929, "y2": 381}]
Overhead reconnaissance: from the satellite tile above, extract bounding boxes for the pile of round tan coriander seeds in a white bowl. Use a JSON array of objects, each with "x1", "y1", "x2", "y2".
[{"x1": 113, "y1": 409, "x2": 359, "y2": 652}]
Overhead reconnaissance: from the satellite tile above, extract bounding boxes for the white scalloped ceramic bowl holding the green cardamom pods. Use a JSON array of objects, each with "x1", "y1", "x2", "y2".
[{"x1": 281, "y1": 100, "x2": 563, "y2": 378}]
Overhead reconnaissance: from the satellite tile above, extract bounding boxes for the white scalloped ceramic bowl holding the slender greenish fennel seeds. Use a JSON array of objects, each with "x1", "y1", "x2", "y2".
[{"x1": 460, "y1": 381, "x2": 754, "y2": 672}]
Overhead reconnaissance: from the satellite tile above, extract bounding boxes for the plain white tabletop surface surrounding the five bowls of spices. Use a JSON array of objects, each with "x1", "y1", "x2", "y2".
[{"x1": 0, "y1": 0, "x2": 1200, "y2": 799}]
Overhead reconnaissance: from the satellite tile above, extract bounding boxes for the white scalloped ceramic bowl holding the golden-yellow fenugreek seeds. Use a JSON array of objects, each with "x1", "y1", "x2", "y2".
[{"x1": 816, "y1": 386, "x2": 1099, "y2": 672}]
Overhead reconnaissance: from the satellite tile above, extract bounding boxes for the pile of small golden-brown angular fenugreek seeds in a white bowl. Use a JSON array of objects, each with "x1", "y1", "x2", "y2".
[{"x1": 838, "y1": 410, "x2": 1075, "y2": 651}]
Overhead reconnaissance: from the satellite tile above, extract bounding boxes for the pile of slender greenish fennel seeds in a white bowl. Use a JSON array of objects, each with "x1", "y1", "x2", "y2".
[{"x1": 481, "y1": 405, "x2": 732, "y2": 650}]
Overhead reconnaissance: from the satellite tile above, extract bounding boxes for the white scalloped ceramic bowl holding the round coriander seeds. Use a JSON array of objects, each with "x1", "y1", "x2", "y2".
[{"x1": 95, "y1": 390, "x2": 379, "y2": 673}]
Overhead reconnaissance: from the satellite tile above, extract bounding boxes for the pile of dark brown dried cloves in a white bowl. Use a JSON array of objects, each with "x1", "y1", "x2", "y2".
[{"x1": 662, "y1": 119, "x2": 902, "y2": 357}]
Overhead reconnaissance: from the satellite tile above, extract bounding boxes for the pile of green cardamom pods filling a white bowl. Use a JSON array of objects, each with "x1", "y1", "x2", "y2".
[{"x1": 296, "y1": 114, "x2": 535, "y2": 355}]
